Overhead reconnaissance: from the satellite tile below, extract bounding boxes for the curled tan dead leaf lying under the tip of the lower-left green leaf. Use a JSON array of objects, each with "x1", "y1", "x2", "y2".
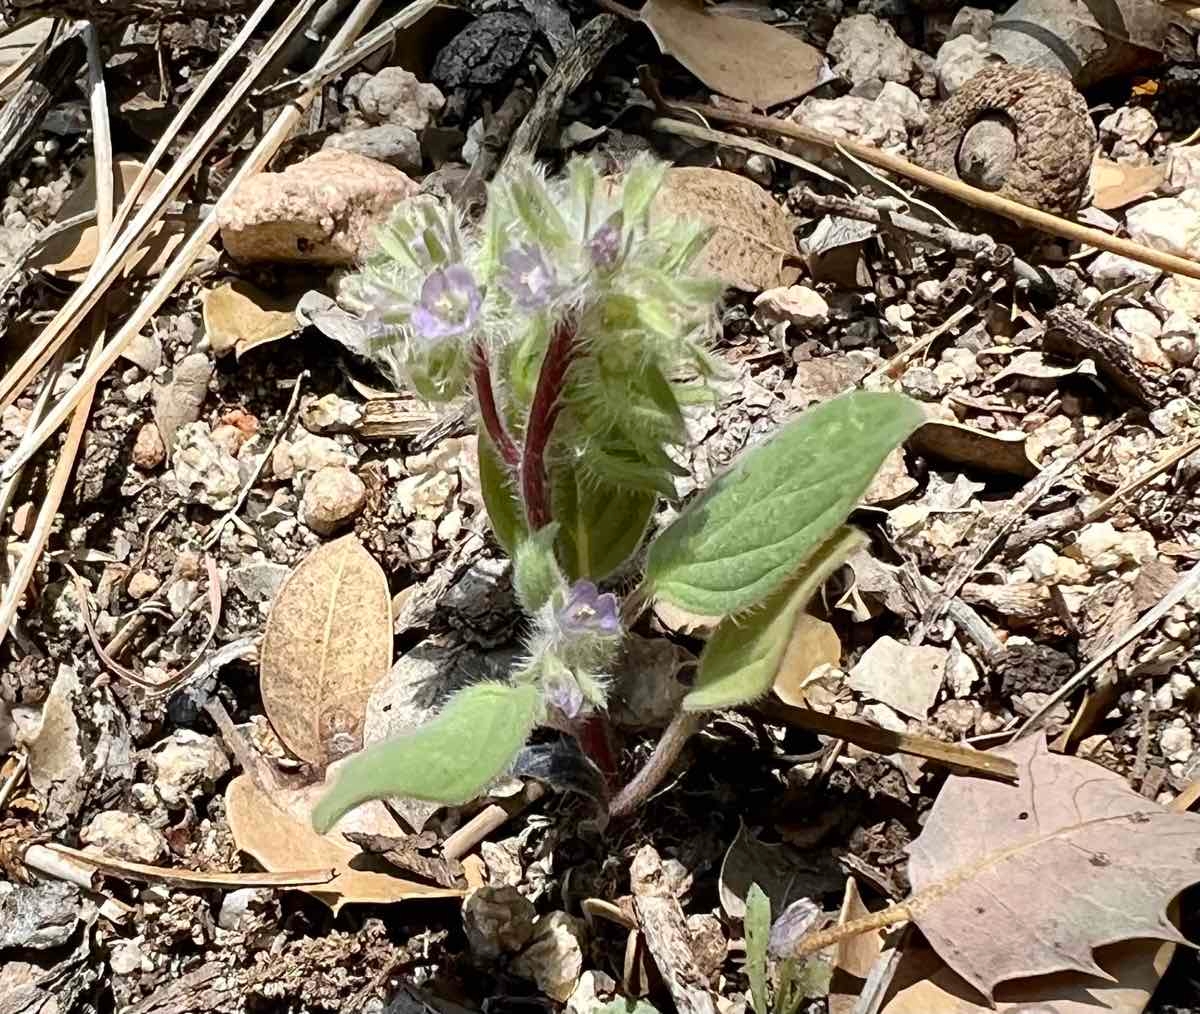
[{"x1": 226, "y1": 769, "x2": 462, "y2": 914}]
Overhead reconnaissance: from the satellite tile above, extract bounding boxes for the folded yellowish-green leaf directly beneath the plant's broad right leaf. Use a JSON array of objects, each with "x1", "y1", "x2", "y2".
[{"x1": 683, "y1": 528, "x2": 866, "y2": 712}]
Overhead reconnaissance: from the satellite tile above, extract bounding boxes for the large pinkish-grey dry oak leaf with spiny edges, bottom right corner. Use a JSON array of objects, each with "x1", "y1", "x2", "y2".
[{"x1": 902, "y1": 736, "x2": 1200, "y2": 1000}]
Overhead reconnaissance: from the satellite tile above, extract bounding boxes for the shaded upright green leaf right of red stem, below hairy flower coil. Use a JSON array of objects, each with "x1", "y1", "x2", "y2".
[{"x1": 553, "y1": 462, "x2": 658, "y2": 581}]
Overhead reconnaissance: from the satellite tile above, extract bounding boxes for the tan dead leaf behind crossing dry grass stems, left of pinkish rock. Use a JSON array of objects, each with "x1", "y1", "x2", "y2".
[{"x1": 30, "y1": 158, "x2": 217, "y2": 282}]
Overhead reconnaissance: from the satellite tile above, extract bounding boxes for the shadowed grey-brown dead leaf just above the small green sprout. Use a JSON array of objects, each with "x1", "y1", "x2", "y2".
[{"x1": 718, "y1": 824, "x2": 842, "y2": 919}]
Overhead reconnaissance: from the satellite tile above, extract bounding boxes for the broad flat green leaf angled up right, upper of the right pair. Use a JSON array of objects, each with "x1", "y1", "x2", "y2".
[{"x1": 646, "y1": 391, "x2": 924, "y2": 616}]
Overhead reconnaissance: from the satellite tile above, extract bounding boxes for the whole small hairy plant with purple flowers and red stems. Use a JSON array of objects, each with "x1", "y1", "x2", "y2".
[{"x1": 314, "y1": 158, "x2": 922, "y2": 829}]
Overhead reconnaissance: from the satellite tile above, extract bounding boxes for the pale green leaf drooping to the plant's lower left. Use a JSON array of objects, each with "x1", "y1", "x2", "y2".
[{"x1": 312, "y1": 683, "x2": 541, "y2": 834}]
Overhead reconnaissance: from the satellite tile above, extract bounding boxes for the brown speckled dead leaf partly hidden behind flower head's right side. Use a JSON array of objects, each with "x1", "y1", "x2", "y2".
[{"x1": 654, "y1": 167, "x2": 799, "y2": 293}]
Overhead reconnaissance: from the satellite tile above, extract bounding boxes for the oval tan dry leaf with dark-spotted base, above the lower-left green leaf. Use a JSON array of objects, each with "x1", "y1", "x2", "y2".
[{"x1": 259, "y1": 535, "x2": 391, "y2": 764}]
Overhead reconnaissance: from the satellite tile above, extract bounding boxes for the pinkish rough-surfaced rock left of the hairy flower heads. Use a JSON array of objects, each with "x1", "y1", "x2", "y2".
[{"x1": 217, "y1": 149, "x2": 418, "y2": 265}]
